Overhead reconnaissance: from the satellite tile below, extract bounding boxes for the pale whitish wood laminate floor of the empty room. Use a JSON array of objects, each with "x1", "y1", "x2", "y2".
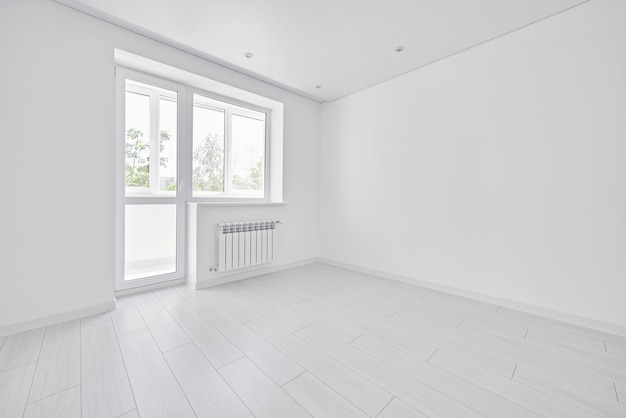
[{"x1": 0, "y1": 264, "x2": 626, "y2": 418}]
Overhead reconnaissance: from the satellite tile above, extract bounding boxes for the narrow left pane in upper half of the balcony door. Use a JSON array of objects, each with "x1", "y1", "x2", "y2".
[{"x1": 125, "y1": 91, "x2": 150, "y2": 192}]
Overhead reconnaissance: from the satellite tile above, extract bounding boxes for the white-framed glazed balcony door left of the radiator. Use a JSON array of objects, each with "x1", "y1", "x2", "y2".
[{"x1": 116, "y1": 68, "x2": 185, "y2": 290}]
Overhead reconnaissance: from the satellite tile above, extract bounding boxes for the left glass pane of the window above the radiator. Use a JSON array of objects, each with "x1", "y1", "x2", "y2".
[{"x1": 192, "y1": 96, "x2": 224, "y2": 196}]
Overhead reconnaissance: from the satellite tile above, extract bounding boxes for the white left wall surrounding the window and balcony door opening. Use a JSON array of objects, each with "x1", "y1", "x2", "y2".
[{"x1": 0, "y1": 0, "x2": 320, "y2": 332}]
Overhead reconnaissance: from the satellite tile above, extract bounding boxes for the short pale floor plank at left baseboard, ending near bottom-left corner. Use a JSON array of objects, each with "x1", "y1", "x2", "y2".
[{"x1": 28, "y1": 319, "x2": 80, "y2": 403}]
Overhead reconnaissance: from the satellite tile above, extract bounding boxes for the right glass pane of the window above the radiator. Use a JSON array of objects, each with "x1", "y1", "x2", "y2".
[{"x1": 231, "y1": 115, "x2": 265, "y2": 197}]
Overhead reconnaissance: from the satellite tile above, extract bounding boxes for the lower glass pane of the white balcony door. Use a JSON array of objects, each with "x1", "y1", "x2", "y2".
[{"x1": 124, "y1": 204, "x2": 176, "y2": 280}]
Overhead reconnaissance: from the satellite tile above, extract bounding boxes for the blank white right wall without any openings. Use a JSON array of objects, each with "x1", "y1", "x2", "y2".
[{"x1": 321, "y1": 0, "x2": 626, "y2": 327}]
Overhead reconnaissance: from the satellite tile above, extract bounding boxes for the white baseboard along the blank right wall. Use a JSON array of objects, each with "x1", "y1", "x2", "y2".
[{"x1": 319, "y1": 258, "x2": 626, "y2": 337}]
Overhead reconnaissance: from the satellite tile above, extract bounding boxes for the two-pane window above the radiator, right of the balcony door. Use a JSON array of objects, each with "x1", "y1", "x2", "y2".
[{"x1": 192, "y1": 94, "x2": 267, "y2": 198}]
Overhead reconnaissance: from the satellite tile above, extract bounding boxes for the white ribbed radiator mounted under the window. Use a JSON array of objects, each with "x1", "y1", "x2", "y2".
[{"x1": 217, "y1": 220, "x2": 279, "y2": 271}]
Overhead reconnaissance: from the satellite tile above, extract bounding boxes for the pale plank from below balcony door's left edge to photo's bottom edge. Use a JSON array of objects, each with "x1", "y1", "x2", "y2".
[{"x1": 119, "y1": 330, "x2": 196, "y2": 418}]
